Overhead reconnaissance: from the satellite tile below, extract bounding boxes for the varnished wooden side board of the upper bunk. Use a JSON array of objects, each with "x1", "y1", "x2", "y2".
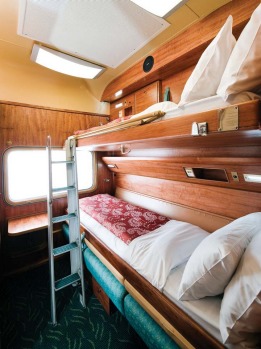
[{"x1": 78, "y1": 100, "x2": 261, "y2": 150}]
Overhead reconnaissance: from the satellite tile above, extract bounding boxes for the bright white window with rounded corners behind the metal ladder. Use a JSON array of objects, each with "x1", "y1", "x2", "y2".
[{"x1": 3, "y1": 147, "x2": 97, "y2": 206}]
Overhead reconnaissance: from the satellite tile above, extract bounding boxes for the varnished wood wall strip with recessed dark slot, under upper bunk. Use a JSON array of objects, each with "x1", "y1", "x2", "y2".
[{"x1": 103, "y1": 157, "x2": 261, "y2": 192}]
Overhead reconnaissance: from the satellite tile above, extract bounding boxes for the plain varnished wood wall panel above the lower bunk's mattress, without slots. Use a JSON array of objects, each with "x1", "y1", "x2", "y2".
[{"x1": 116, "y1": 174, "x2": 261, "y2": 219}]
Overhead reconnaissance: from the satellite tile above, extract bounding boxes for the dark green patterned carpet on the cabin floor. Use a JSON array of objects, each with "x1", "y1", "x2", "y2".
[{"x1": 0, "y1": 259, "x2": 147, "y2": 349}]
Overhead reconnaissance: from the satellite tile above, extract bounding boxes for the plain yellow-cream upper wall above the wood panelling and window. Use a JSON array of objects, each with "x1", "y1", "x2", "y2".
[{"x1": 0, "y1": 40, "x2": 109, "y2": 114}]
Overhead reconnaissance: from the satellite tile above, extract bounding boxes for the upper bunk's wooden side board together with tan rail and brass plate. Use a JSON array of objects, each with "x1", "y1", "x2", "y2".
[{"x1": 75, "y1": 99, "x2": 261, "y2": 153}]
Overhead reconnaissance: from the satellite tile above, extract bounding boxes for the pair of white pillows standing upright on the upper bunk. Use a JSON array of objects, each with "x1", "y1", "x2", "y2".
[{"x1": 178, "y1": 4, "x2": 261, "y2": 107}]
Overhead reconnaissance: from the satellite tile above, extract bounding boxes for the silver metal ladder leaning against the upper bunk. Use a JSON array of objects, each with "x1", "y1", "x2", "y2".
[{"x1": 46, "y1": 136, "x2": 85, "y2": 325}]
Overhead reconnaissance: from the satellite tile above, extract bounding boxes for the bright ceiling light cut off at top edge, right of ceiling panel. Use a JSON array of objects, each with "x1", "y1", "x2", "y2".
[{"x1": 131, "y1": 0, "x2": 186, "y2": 17}]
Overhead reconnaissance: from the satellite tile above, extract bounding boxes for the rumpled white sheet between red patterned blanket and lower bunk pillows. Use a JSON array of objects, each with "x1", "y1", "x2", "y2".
[{"x1": 125, "y1": 220, "x2": 209, "y2": 291}]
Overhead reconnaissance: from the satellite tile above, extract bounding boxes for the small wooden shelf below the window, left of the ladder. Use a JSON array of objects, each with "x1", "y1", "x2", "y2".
[{"x1": 8, "y1": 213, "x2": 48, "y2": 236}]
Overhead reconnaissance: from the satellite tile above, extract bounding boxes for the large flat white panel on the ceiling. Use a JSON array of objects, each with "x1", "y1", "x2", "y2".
[{"x1": 18, "y1": 0, "x2": 169, "y2": 68}]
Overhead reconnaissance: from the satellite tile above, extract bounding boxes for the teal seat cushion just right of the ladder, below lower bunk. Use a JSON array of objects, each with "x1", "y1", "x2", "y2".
[{"x1": 83, "y1": 248, "x2": 127, "y2": 315}]
